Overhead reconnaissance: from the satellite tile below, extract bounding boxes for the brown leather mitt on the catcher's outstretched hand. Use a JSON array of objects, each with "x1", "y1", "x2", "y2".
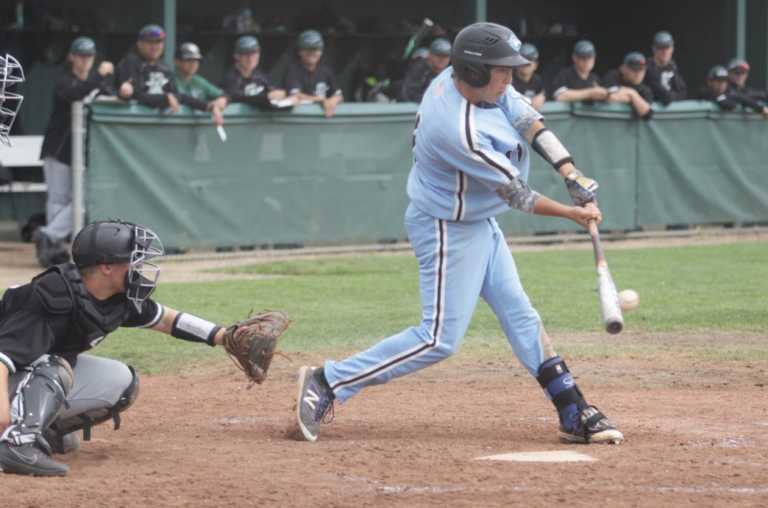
[{"x1": 224, "y1": 311, "x2": 290, "y2": 386}]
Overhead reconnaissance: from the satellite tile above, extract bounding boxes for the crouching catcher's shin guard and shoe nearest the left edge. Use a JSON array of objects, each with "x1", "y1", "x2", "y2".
[{"x1": 0, "y1": 355, "x2": 73, "y2": 476}]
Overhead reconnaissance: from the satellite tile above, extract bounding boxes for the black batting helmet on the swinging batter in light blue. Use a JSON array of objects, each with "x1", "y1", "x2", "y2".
[{"x1": 451, "y1": 23, "x2": 530, "y2": 88}]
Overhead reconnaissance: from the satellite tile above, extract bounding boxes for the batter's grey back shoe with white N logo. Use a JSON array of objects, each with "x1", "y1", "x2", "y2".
[{"x1": 296, "y1": 366, "x2": 334, "y2": 442}]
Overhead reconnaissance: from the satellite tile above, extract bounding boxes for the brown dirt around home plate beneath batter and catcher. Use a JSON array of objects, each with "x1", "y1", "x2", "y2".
[{"x1": 0, "y1": 334, "x2": 768, "y2": 508}]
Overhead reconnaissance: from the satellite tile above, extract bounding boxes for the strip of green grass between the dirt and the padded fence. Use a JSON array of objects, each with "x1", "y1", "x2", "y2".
[{"x1": 95, "y1": 243, "x2": 768, "y2": 372}]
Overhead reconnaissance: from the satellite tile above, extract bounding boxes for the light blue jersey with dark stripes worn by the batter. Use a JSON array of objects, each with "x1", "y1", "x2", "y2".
[{"x1": 408, "y1": 67, "x2": 542, "y2": 221}]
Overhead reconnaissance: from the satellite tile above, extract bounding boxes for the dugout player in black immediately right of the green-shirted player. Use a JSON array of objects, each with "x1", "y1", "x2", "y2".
[{"x1": 221, "y1": 35, "x2": 286, "y2": 111}]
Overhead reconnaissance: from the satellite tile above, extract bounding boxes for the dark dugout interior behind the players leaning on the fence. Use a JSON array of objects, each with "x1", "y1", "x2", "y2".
[{"x1": 0, "y1": 0, "x2": 768, "y2": 135}]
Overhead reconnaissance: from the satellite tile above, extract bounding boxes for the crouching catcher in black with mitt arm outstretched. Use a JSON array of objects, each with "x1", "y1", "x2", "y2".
[{"x1": 0, "y1": 221, "x2": 288, "y2": 476}]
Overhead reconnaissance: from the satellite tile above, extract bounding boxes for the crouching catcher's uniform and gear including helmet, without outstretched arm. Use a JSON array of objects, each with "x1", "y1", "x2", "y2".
[{"x1": 0, "y1": 222, "x2": 163, "y2": 476}]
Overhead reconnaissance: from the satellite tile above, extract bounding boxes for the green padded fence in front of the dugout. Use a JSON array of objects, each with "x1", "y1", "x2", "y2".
[{"x1": 85, "y1": 102, "x2": 768, "y2": 248}]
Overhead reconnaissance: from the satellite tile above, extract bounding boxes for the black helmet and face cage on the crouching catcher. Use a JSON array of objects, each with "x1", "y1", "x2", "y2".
[{"x1": 72, "y1": 221, "x2": 165, "y2": 311}]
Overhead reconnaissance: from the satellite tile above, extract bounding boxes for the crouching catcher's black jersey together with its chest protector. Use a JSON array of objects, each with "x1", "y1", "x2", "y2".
[{"x1": 0, "y1": 263, "x2": 163, "y2": 372}]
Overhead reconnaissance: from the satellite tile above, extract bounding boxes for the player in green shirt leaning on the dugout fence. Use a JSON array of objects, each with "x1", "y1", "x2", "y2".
[{"x1": 174, "y1": 42, "x2": 227, "y2": 125}]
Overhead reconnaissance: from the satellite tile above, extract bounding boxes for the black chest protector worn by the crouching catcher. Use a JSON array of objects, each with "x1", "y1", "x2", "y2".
[{"x1": 32, "y1": 263, "x2": 128, "y2": 349}]
